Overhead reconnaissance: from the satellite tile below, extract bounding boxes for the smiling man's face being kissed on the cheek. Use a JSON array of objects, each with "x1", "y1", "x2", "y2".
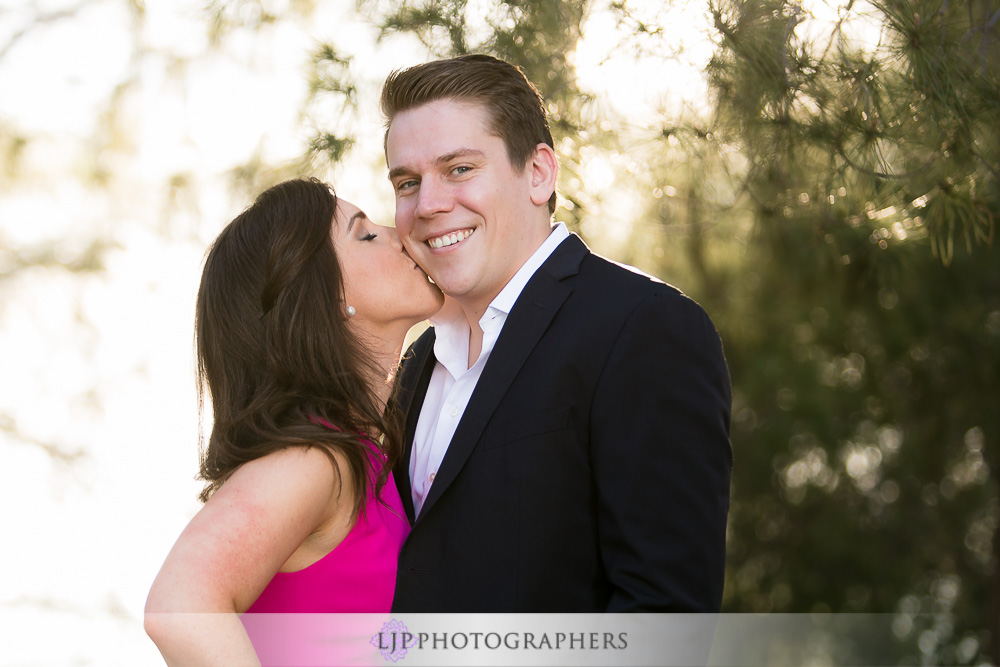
[{"x1": 386, "y1": 100, "x2": 548, "y2": 313}]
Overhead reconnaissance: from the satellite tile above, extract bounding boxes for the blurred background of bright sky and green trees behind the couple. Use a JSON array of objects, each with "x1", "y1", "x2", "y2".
[{"x1": 0, "y1": 0, "x2": 1000, "y2": 665}]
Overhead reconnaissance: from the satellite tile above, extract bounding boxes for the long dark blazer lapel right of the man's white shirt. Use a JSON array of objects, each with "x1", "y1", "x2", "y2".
[{"x1": 411, "y1": 235, "x2": 590, "y2": 520}]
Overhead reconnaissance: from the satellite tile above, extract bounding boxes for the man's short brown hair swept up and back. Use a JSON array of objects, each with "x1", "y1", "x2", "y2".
[{"x1": 382, "y1": 54, "x2": 556, "y2": 213}]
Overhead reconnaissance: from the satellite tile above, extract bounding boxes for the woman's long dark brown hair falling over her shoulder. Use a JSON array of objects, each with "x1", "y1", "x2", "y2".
[{"x1": 195, "y1": 179, "x2": 399, "y2": 513}]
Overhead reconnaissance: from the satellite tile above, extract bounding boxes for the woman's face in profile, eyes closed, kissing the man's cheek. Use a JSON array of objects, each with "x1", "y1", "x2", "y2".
[{"x1": 331, "y1": 198, "x2": 444, "y2": 333}]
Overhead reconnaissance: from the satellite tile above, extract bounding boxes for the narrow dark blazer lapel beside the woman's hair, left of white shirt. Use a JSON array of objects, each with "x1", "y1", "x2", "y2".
[{"x1": 393, "y1": 328, "x2": 435, "y2": 524}]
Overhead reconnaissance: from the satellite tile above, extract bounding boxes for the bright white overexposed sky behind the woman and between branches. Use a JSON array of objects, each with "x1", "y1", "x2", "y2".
[{"x1": 0, "y1": 0, "x2": 876, "y2": 667}]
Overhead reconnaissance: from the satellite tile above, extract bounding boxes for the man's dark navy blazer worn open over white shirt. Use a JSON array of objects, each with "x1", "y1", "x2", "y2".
[{"x1": 393, "y1": 235, "x2": 732, "y2": 612}]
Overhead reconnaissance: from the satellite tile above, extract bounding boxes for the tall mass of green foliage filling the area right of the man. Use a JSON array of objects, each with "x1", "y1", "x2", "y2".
[{"x1": 708, "y1": 1, "x2": 1000, "y2": 664}]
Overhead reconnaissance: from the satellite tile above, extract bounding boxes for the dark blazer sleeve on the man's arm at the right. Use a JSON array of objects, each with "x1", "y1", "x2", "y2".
[{"x1": 591, "y1": 288, "x2": 732, "y2": 612}]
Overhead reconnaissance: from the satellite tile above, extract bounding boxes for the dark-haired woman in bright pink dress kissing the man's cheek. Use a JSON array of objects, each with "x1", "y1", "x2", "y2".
[{"x1": 145, "y1": 180, "x2": 444, "y2": 665}]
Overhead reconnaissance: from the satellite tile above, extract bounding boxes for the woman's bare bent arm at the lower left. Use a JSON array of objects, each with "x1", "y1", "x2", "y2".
[{"x1": 145, "y1": 447, "x2": 354, "y2": 665}]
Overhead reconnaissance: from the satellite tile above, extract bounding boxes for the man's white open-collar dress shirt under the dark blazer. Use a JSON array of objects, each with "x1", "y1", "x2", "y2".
[{"x1": 410, "y1": 222, "x2": 569, "y2": 515}]
